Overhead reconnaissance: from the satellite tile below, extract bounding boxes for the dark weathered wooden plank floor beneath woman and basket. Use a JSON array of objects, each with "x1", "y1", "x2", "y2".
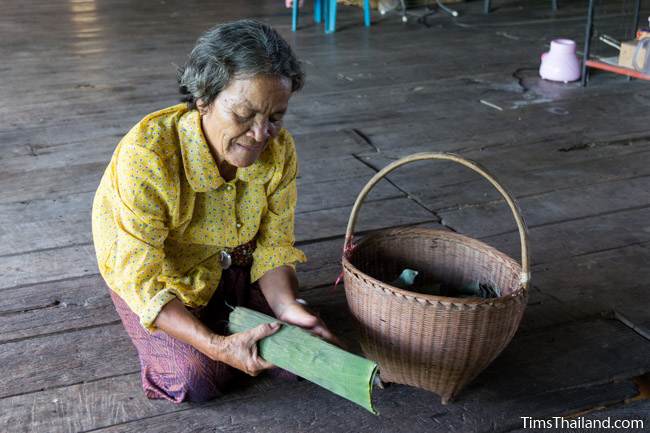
[{"x1": 0, "y1": 0, "x2": 650, "y2": 433}]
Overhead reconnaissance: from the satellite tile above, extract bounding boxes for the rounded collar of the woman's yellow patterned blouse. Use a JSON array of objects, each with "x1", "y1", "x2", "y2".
[{"x1": 178, "y1": 110, "x2": 274, "y2": 192}]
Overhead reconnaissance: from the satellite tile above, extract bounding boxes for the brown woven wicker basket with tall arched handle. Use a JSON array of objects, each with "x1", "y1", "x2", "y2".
[{"x1": 343, "y1": 153, "x2": 530, "y2": 404}]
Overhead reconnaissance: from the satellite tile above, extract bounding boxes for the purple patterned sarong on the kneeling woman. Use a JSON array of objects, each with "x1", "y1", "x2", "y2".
[{"x1": 109, "y1": 266, "x2": 288, "y2": 403}]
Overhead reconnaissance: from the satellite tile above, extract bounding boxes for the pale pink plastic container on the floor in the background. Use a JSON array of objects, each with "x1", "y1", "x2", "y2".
[{"x1": 539, "y1": 39, "x2": 581, "y2": 83}]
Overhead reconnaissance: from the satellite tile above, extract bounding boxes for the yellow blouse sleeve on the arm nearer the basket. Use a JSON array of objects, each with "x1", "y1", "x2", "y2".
[{"x1": 251, "y1": 133, "x2": 307, "y2": 281}]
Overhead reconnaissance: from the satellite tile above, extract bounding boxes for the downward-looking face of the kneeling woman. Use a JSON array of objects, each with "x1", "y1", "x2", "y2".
[{"x1": 197, "y1": 75, "x2": 291, "y2": 177}]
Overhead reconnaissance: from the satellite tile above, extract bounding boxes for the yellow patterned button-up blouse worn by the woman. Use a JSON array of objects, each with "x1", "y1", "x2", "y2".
[{"x1": 92, "y1": 104, "x2": 306, "y2": 331}]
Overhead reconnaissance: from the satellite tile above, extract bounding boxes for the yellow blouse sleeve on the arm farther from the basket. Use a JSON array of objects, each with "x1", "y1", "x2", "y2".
[{"x1": 111, "y1": 145, "x2": 178, "y2": 332}]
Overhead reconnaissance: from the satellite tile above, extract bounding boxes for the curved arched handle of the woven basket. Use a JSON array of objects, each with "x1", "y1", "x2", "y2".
[{"x1": 343, "y1": 152, "x2": 530, "y2": 287}]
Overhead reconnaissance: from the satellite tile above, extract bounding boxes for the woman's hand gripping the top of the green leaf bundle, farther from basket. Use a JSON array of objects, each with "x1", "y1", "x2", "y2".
[{"x1": 208, "y1": 323, "x2": 280, "y2": 376}]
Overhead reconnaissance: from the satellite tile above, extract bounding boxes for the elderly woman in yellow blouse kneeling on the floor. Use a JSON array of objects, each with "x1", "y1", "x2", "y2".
[{"x1": 92, "y1": 20, "x2": 334, "y2": 402}]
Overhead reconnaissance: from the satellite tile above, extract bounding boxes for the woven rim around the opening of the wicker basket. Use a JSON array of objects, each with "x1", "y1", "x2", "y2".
[{"x1": 341, "y1": 227, "x2": 528, "y2": 306}]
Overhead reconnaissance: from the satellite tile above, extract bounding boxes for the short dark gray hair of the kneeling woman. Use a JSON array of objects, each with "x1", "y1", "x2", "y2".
[{"x1": 178, "y1": 20, "x2": 305, "y2": 108}]
